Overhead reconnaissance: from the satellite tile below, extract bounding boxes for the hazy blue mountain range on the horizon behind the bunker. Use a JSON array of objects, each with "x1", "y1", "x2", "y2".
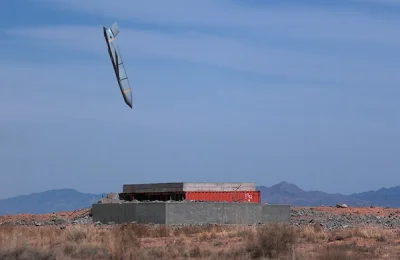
[{"x1": 0, "y1": 181, "x2": 400, "y2": 215}]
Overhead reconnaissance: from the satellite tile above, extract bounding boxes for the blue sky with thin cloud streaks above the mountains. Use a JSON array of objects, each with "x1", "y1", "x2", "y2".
[{"x1": 0, "y1": 0, "x2": 400, "y2": 198}]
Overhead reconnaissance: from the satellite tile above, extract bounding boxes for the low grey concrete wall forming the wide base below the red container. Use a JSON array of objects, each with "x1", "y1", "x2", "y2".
[{"x1": 92, "y1": 202, "x2": 291, "y2": 225}]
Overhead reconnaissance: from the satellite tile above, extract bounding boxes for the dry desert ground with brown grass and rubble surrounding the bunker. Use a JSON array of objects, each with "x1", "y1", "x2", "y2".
[{"x1": 0, "y1": 207, "x2": 400, "y2": 260}]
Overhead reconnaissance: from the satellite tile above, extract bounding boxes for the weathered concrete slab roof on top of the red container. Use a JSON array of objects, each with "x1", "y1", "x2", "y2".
[{"x1": 122, "y1": 182, "x2": 256, "y2": 193}]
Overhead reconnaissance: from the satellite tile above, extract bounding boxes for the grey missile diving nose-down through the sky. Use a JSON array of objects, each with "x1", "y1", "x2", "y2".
[{"x1": 103, "y1": 23, "x2": 132, "y2": 108}]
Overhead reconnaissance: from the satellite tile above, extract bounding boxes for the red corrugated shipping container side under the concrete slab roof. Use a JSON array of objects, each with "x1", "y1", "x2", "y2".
[{"x1": 185, "y1": 191, "x2": 261, "y2": 203}]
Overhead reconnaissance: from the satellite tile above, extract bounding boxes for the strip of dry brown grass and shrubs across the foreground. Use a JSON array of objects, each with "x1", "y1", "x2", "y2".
[{"x1": 0, "y1": 224, "x2": 400, "y2": 260}]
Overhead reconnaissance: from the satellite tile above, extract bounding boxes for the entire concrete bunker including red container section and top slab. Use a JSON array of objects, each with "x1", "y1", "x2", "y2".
[{"x1": 92, "y1": 182, "x2": 291, "y2": 225}]
